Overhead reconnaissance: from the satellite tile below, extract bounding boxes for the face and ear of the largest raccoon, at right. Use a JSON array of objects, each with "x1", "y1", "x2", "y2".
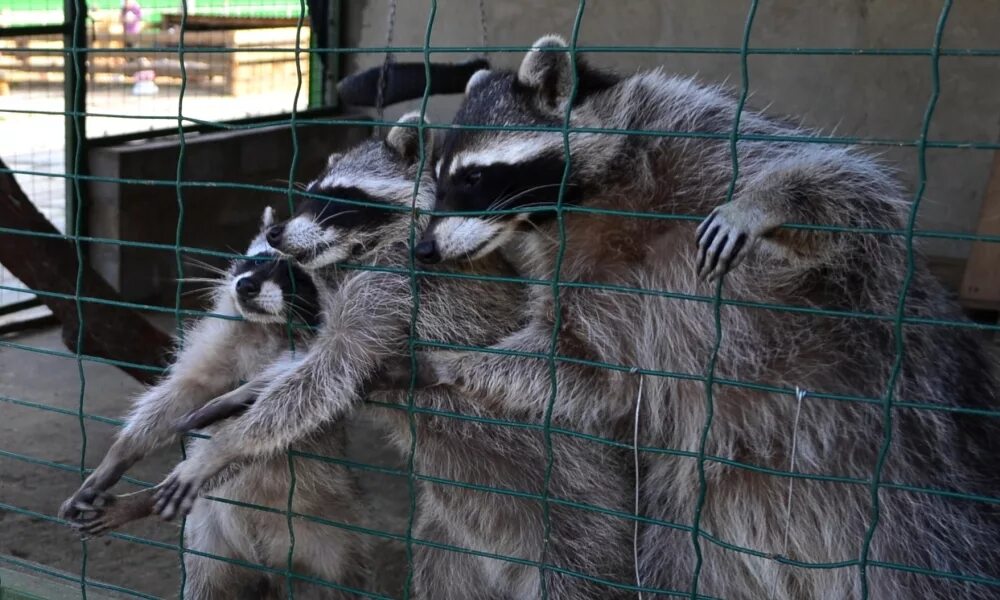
[{"x1": 416, "y1": 36, "x2": 611, "y2": 263}]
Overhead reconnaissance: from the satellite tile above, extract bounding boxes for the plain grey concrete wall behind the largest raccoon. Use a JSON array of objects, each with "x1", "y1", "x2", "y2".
[{"x1": 343, "y1": 0, "x2": 1000, "y2": 257}]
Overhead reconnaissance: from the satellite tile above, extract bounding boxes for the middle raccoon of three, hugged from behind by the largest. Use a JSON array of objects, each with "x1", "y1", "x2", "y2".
[{"x1": 158, "y1": 115, "x2": 631, "y2": 600}]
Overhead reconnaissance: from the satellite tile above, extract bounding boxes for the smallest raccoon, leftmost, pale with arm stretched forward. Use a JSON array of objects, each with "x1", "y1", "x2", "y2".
[{"x1": 60, "y1": 208, "x2": 369, "y2": 599}]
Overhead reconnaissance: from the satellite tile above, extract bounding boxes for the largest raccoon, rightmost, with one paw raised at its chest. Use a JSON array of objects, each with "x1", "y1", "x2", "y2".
[{"x1": 416, "y1": 36, "x2": 1000, "y2": 600}]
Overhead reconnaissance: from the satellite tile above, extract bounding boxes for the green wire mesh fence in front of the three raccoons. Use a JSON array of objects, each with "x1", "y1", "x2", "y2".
[{"x1": 0, "y1": 0, "x2": 1000, "y2": 598}]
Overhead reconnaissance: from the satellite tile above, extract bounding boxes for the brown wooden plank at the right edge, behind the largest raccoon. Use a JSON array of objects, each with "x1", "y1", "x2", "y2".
[{"x1": 959, "y1": 152, "x2": 1000, "y2": 309}]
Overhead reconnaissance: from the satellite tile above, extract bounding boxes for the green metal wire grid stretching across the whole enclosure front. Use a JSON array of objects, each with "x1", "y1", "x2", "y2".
[{"x1": 0, "y1": 0, "x2": 1000, "y2": 599}]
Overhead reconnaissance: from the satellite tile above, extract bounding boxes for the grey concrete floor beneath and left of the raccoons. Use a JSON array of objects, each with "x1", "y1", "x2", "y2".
[{"x1": 0, "y1": 328, "x2": 409, "y2": 598}]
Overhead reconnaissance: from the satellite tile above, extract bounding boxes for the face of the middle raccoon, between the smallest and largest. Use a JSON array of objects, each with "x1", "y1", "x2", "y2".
[{"x1": 265, "y1": 114, "x2": 432, "y2": 270}]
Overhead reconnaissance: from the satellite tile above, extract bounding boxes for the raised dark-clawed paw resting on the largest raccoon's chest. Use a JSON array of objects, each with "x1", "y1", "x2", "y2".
[{"x1": 695, "y1": 203, "x2": 759, "y2": 281}]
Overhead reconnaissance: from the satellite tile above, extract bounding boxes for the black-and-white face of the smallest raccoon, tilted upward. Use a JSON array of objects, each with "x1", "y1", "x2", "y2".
[{"x1": 225, "y1": 207, "x2": 320, "y2": 325}]
